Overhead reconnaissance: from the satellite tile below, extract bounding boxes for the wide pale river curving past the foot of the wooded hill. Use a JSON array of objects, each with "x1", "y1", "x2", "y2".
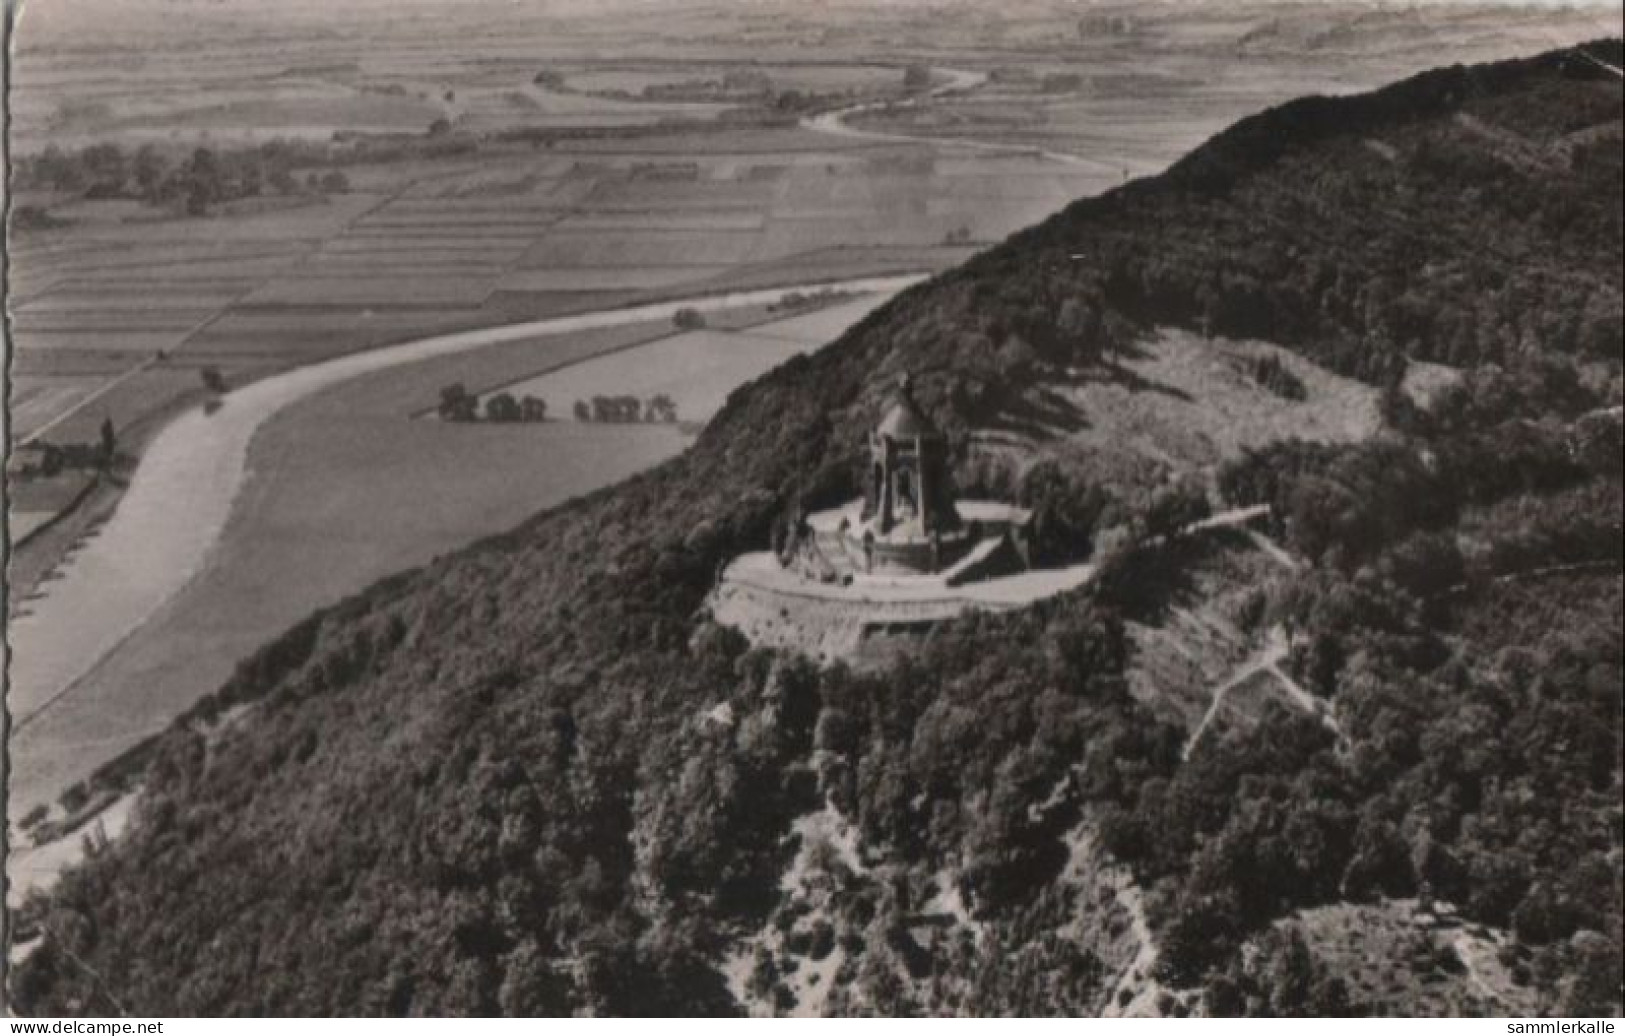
[{"x1": 7, "y1": 274, "x2": 928, "y2": 737}]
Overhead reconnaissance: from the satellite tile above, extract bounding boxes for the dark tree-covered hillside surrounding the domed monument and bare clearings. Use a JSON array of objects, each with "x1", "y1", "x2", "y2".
[{"x1": 11, "y1": 41, "x2": 1622, "y2": 1015}]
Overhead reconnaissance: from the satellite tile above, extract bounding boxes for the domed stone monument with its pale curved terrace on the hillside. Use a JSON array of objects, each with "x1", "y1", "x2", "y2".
[{"x1": 710, "y1": 377, "x2": 1092, "y2": 659}]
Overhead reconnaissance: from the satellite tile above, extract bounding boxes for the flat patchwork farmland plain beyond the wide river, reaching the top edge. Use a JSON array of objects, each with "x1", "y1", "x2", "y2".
[{"x1": 10, "y1": 0, "x2": 1578, "y2": 503}]
